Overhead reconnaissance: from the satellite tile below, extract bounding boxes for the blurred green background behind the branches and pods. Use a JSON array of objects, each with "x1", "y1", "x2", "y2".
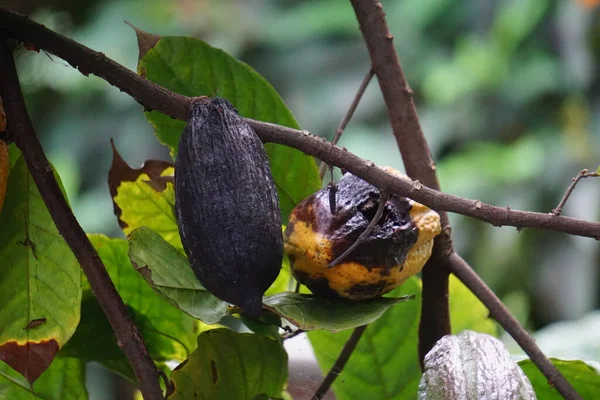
[{"x1": 3, "y1": 0, "x2": 600, "y2": 396}]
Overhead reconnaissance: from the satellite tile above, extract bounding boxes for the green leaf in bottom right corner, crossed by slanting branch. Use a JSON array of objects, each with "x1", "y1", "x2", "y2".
[{"x1": 519, "y1": 358, "x2": 600, "y2": 400}]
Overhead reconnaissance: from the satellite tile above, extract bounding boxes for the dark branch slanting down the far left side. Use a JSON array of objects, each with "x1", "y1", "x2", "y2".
[{"x1": 0, "y1": 37, "x2": 163, "y2": 400}]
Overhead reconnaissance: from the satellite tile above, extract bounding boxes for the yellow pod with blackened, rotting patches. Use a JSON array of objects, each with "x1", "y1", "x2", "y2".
[{"x1": 284, "y1": 168, "x2": 441, "y2": 300}]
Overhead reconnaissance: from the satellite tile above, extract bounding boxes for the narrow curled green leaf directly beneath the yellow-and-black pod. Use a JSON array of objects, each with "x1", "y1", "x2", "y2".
[{"x1": 263, "y1": 292, "x2": 411, "y2": 332}]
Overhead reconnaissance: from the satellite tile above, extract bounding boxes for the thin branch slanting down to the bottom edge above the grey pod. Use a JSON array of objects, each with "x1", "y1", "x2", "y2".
[{"x1": 448, "y1": 253, "x2": 581, "y2": 400}]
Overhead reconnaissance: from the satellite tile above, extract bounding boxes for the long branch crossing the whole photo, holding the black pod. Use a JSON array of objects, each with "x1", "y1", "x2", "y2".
[{"x1": 0, "y1": 7, "x2": 600, "y2": 240}]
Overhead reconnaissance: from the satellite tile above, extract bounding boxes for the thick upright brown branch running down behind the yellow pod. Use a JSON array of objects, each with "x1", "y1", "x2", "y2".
[{"x1": 351, "y1": 0, "x2": 453, "y2": 362}]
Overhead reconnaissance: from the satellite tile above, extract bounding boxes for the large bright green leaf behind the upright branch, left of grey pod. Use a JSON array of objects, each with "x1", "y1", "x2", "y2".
[{"x1": 308, "y1": 277, "x2": 497, "y2": 400}]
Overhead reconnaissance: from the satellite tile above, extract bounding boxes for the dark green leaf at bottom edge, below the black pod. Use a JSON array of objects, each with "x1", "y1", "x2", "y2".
[{"x1": 169, "y1": 329, "x2": 288, "y2": 400}]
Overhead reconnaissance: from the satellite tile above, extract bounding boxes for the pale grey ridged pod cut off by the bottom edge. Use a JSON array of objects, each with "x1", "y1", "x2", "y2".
[{"x1": 419, "y1": 331, "x2": 536, "y2": 400}]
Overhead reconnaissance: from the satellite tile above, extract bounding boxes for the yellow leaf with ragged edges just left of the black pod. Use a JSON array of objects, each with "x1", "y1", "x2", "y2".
[{"x1": 114, "y1": 168, "x2": 183, "y2": 251}]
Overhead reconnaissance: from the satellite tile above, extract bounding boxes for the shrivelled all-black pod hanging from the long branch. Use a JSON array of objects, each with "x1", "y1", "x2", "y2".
[{"x1": 175, "y1": 98, "x2": 283, "y2": 316}]
